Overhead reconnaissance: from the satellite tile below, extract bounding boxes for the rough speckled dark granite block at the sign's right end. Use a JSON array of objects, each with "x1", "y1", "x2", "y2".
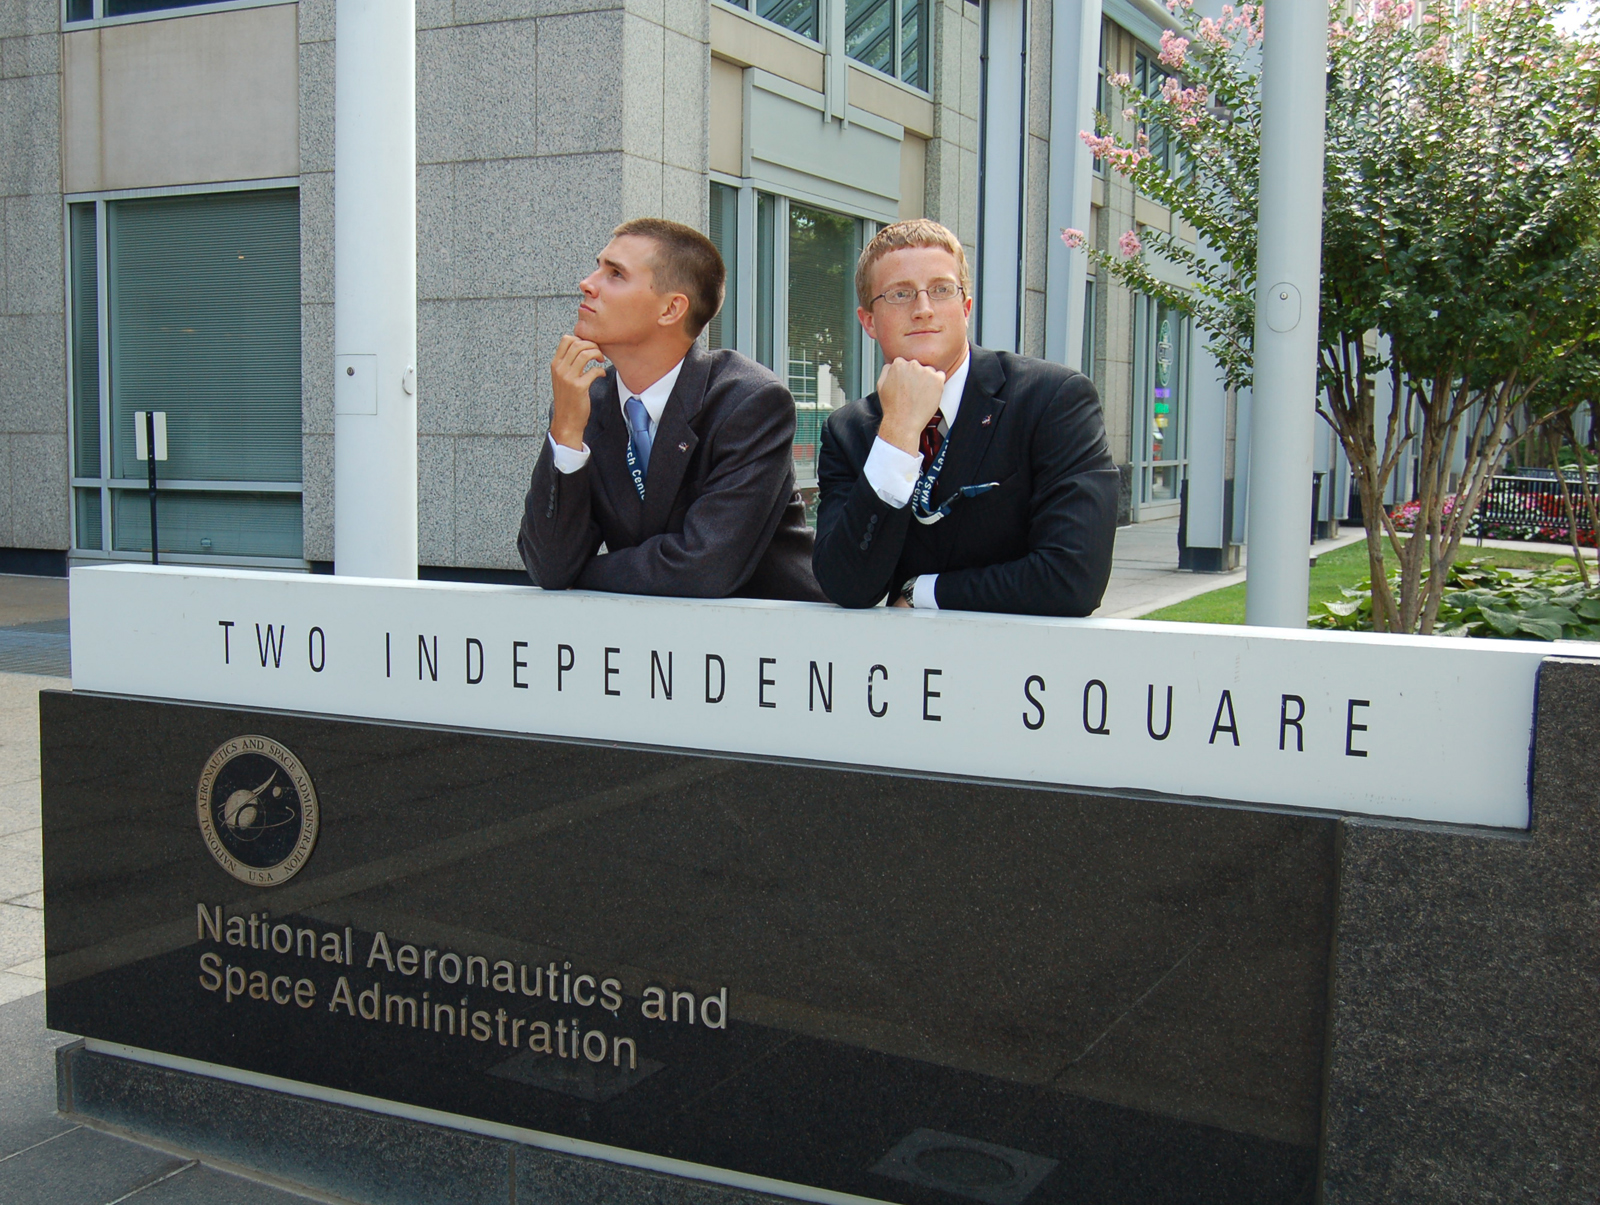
[{"x1": 1323, "y1": 658, "x2": 1600, "y2": 1205}]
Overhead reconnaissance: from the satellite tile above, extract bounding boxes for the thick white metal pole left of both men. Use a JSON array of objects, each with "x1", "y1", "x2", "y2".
[{"x1": 333, "y1": 0, "x2": 418, "y2": 579}]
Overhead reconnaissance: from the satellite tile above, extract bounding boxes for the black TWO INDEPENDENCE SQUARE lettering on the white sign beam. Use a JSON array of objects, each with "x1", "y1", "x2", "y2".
[{"x1": 218, "y1": 619, "x2": 1371, "y2": 757}]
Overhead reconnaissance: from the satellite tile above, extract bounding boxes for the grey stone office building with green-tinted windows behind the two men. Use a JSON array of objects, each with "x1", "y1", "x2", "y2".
[{"x1": 0, "y1": 0, "x2": 1273, "y2": 576}]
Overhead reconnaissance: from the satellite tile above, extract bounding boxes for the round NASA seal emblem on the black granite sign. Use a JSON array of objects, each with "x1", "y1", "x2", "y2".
[{"x1": 195, "y1": 736, "x2": 320, "y2": 887}]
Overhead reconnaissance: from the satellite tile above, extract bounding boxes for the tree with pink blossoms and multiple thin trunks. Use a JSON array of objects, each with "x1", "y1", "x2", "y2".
[{"x1": 1062, "y1": 0, "x2": 1600, "y2": 634}]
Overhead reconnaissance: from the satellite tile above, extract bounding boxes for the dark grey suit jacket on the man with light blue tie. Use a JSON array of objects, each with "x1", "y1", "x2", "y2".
[{"x1": 517, "y1": 344, "x2": 822, "y2": 602}]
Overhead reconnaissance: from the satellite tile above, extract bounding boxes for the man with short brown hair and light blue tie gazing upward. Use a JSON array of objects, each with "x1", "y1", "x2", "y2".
[{"x1": 517, "y1": 218, "x2": 822, "y2": 600}]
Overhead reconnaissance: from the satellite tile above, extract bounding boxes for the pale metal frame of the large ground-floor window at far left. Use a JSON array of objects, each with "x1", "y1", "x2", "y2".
[{"x1": 61, "y1": 177, "x2": 310, "y2": 570}]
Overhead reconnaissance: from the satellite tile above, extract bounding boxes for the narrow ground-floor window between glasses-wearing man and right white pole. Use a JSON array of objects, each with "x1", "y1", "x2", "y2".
[{"x1": 1133, "y1": 294, "x2": 1190, "y2": 518}]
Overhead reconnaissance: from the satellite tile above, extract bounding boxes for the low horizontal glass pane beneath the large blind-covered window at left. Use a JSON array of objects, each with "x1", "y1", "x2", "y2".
[{"x1": 110, "y1": 490, "x2": 302, "y2": 558}]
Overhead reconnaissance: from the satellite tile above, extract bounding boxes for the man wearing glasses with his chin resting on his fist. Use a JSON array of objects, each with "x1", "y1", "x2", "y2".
[{"x1": 813, "y1": 218, "x2": 1118, "y2": 615}]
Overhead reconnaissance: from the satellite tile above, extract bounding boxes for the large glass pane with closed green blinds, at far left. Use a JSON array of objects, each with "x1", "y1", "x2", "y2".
[{"x1": 107, "y1": 189, "x2": 301, "y2": 482}]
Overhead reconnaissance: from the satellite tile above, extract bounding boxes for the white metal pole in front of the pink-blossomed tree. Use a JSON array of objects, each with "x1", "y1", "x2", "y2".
[{"x1": 1245, "y1": 0, "x2": 1328, "y2": 627}]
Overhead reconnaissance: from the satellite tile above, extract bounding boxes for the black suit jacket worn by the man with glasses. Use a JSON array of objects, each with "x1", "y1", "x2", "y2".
[{"x1": 813, "y1": 347, "x2": 1118, "y2": 615}]
